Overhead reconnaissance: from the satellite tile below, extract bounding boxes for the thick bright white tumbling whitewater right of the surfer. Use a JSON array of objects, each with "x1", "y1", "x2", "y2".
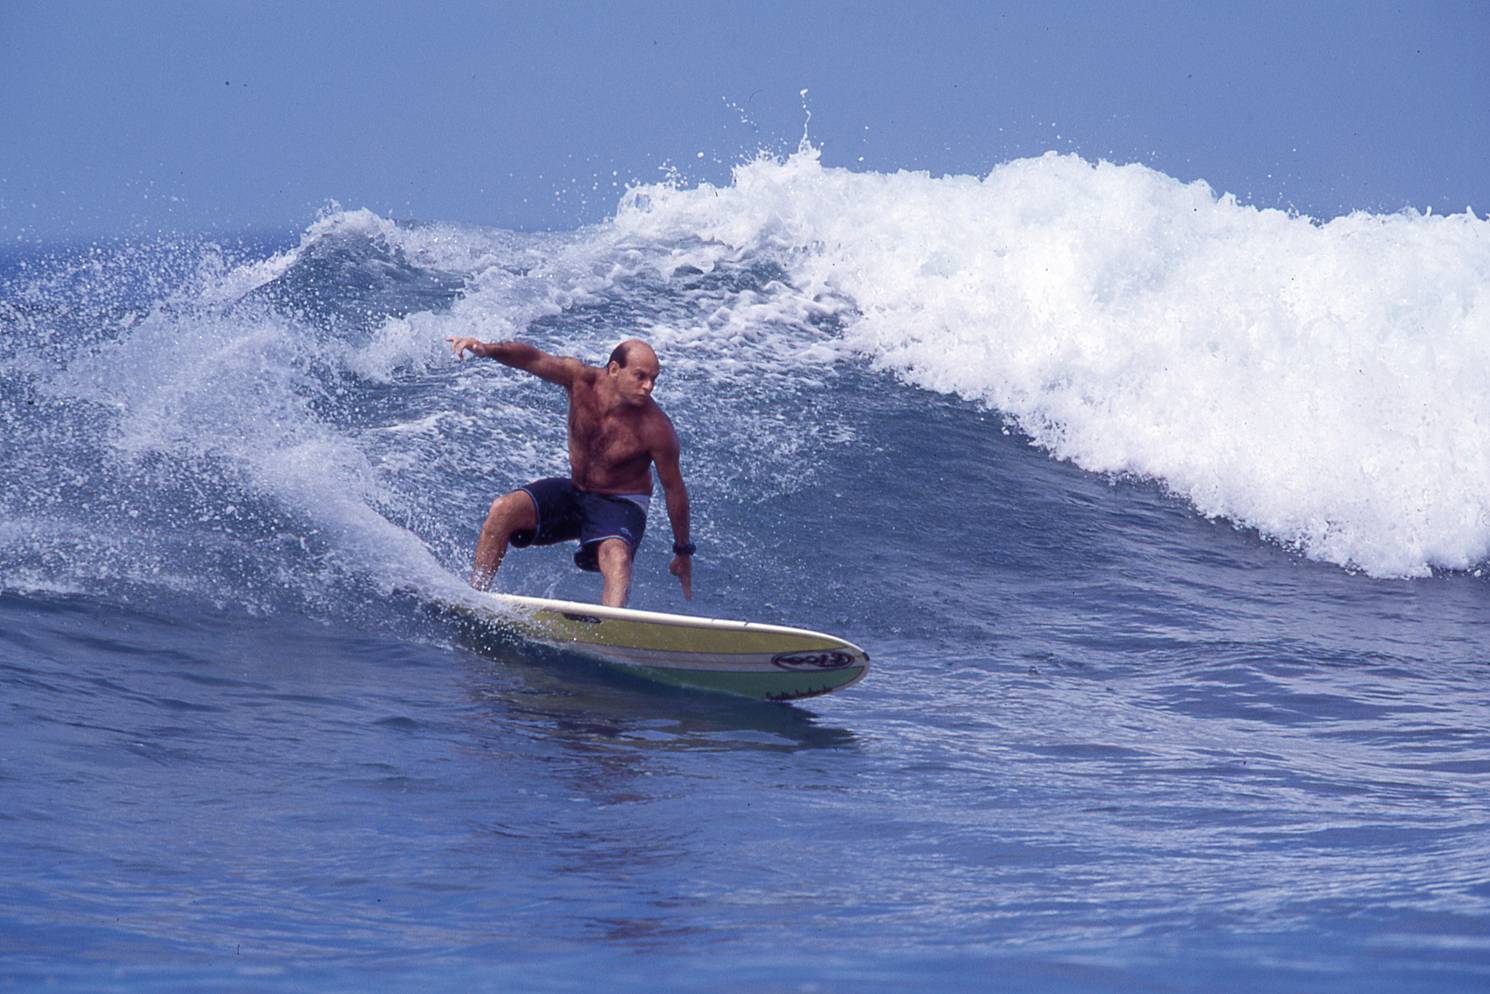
[{"x1": 614, "y1": 149, "x2": 1490, "y2": 577}]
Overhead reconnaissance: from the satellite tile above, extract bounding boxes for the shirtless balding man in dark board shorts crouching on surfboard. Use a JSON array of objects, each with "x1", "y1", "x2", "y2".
[{"x1": 447, "y1": 338, "x2": 693, "y2": 608}]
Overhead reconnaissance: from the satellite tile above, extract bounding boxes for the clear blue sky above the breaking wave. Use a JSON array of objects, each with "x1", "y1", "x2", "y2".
[{"x1": 0, "y1": 0, "x2": 1490, "y2": 246}]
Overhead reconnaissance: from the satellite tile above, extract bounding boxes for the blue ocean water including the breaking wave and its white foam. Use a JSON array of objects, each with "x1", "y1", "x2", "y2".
[{"x1": 0, "y1": 149, "x2": 1490, "y2": 993}]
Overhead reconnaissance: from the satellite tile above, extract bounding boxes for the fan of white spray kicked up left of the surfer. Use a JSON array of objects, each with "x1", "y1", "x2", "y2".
[{"x1": 48, "y1": 280, "x2": 444, "y2": 598}]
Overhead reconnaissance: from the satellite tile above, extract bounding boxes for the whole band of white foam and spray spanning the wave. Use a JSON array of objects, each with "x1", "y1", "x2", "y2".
[{"x1": 6, "y1": 148, "x2": 1490, "y2": 599}]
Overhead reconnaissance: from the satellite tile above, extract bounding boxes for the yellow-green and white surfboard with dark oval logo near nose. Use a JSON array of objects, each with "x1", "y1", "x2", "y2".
[{"x1": 446, "y1": 592, "x2": 869, "y2": 700}]
